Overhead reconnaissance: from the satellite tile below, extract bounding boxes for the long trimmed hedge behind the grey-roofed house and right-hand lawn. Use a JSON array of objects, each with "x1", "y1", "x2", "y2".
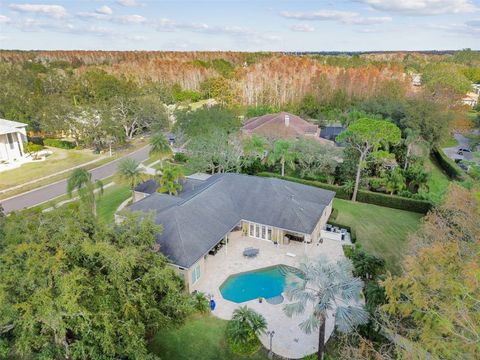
[{"x1": 257, "y1": 172, "x2": 432, "y2": 214}]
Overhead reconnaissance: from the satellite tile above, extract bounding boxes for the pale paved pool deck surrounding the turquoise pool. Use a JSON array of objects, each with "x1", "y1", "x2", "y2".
[{"x1": 193, "y1": 232, "x2": 344, "y2": 359}]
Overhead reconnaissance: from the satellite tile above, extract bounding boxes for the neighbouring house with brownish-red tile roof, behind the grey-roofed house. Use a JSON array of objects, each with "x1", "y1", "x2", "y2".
[{"x1": 241, "y1": 112, "x2": 332, "y2": 141}]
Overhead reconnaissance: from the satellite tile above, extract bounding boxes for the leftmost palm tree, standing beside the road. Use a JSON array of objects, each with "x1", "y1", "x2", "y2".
[{"x1": 67, "y1": 168, "x2": 103, "y2": 216}]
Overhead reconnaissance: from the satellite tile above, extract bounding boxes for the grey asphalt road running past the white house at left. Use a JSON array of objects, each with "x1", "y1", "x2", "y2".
[{"x1": 0, "y1": 146, "x2": 149, "y2": 213}]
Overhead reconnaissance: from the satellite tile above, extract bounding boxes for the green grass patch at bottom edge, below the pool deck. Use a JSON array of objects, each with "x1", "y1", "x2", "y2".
[{"x1": 150, "y1": 315, "x2": 267, "y2": 360}]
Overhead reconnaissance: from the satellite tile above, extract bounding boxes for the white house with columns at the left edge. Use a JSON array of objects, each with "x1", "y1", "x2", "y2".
[{"x1": 0, "y1": 119, "x2": 27, "y2": 163}]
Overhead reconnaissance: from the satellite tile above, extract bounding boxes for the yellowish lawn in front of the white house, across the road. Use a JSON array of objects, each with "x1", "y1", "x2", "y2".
[{"x1": 0, "y1": 148, "x2": 100, "y2": 190}]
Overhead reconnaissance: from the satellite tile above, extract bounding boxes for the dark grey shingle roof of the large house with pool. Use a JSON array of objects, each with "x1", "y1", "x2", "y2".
[{"x1": 128, "y1": 174, "x2": 335, "y2": 268}]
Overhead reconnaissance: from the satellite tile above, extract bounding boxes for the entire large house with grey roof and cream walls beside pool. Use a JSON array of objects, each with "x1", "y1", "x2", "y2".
[{"x1": 127, "y1": 173, "x2": 335, "y2": 290}]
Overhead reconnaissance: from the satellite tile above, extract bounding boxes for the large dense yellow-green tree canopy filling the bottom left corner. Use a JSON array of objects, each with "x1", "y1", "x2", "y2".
[{"x1": 0, "y1": 204, "x2": 189, "y2": 359}]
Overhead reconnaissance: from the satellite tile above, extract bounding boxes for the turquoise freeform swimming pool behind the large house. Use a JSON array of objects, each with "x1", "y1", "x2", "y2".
[{"x1": 220, "y1": 265, "x2": 299, "y2": 303}]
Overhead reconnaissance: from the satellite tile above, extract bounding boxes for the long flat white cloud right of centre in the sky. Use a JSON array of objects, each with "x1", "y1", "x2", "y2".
[{"x1": 280, "y1": 10, "x2": 392, "y2": 25}]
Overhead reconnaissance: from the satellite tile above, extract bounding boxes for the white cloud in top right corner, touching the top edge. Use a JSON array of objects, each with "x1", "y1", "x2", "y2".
[{"x1": 356, "y1": 0, "x2": 479, "y2": 15}]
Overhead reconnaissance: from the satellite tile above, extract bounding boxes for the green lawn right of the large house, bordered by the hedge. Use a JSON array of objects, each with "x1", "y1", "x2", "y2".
[{"x1": 333, "y1": 199, "x2": 422, "y2": 273}]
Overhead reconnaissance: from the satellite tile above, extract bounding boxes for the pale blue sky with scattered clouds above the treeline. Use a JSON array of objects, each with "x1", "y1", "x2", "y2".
[{"x1": 0, "y1": 0, "x2": 480, "y2": 51}]
